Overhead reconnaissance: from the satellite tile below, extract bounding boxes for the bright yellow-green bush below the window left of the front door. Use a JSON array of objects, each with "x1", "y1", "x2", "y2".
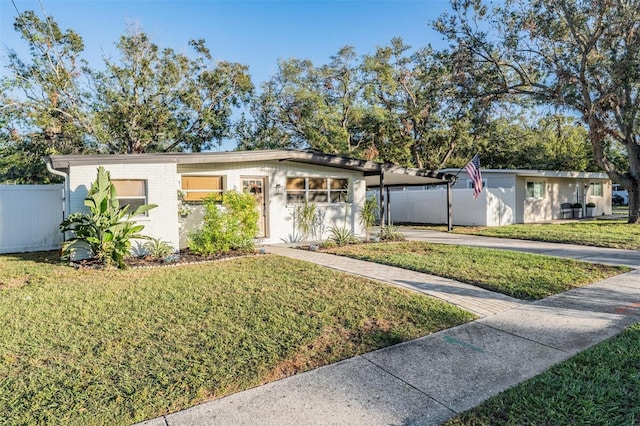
[{"x1": 189, "y1": 191, "x2": 260, "y2": 255}]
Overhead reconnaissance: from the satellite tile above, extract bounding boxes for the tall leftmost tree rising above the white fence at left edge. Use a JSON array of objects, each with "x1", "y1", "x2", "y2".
[{"x1": 0, "y1": 11, "x2": 96, "y2": 183}]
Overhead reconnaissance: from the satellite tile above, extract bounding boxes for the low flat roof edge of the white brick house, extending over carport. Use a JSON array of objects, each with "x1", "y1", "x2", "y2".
[{"x1": 48, "y1": 149, "x2": 455, "y2": 187}]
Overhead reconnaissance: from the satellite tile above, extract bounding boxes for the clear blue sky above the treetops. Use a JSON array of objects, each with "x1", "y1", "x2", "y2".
[{"x1": 0, "y1": 0, "x2": 456, "y2": 149}]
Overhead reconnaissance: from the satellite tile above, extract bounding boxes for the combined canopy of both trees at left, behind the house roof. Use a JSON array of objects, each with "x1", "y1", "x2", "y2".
[{"x1": 0, "y1": 11, "x2": 253, "y2": 183}]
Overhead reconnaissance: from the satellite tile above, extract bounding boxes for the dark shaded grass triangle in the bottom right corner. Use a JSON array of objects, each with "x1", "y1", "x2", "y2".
[{"x1": 446, "y1": 324, "x2": 640, "y2": 426}]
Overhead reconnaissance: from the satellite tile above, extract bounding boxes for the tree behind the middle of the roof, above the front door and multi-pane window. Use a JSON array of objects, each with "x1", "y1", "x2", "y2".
[{"x1": 240, "y1": 46, "x2": 367, "y2": 156}]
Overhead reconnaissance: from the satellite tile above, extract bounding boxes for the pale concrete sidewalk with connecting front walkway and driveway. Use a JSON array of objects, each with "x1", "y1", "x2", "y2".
[{"x1": 144, "y1": 231, "x2": 640, "y2": 426}]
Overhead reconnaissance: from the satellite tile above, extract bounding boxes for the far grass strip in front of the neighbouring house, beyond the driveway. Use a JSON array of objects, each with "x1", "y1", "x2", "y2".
[{"x1": 418, "y1": 219, "x2": 640, "y2": 250}]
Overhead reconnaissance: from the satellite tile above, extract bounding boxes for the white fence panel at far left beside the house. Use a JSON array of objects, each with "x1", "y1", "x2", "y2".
[{"x1": 0, "y1": 185, "x2": 63, "y2": 253}]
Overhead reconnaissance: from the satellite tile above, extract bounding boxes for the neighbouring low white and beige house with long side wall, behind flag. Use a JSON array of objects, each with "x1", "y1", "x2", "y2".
[{"x1": 382, "y1": 169, "x2": 612, "y2": 226}]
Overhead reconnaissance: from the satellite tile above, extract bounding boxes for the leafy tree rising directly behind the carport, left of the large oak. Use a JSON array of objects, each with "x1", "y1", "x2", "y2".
[{"x1": 364, "y1": 38, "x2": 487, "y2": 169}]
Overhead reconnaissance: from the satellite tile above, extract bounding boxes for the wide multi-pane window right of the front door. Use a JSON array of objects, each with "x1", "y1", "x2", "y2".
[{"x1": 287, "y1": 177, "x2": 349, "y2": 204}]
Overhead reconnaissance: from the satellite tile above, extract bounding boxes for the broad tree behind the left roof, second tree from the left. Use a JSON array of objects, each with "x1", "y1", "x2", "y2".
[{"x1": 94, "y1": 28, "x2": 253, "y2": 153}]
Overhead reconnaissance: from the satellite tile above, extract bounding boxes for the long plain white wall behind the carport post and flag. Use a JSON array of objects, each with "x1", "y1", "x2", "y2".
[{"x1": 378, "y1": 188, "x2": 516, "y2": 226}]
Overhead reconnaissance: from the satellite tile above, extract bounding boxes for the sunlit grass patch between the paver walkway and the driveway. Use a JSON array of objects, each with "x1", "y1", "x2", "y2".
[{"x1": 327, "y1": 242, "x2": 629, "y2": 300}]
